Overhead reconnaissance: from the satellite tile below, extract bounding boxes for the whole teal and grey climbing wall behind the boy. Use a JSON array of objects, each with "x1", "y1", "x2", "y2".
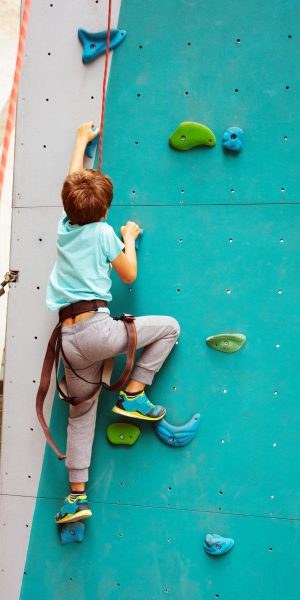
[{"x1": 1, "y1": 0, "x2": 300, "y2": 600}]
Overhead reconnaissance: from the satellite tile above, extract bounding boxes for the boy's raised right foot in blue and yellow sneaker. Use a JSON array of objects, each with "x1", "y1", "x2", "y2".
[{"x1": 112, "y1": 391, "x2": 167, "y2": 421}]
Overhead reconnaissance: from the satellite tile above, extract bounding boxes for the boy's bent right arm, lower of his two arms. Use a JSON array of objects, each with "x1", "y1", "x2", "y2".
[{"x1": 112, "y1": 221, "x2": 140, "y2": 283}]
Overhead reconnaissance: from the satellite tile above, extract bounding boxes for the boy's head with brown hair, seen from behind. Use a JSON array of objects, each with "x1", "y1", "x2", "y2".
[{"x1": 61, "y1": 169, "x2": 113, "y2": 225}]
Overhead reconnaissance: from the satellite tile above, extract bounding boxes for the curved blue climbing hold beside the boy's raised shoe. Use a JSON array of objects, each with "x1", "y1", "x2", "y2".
[{"x1": 154, "y1": 413, "x2": 200, "y2": 446}]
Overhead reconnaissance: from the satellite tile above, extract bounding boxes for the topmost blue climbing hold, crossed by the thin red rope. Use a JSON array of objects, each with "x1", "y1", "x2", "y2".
[{"x1": 78, "y1": 29, "x2": 127, "y2": 64}]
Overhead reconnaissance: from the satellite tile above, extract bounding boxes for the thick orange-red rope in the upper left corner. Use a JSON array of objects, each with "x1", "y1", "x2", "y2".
[{"x1": 0, "y1": 0, "x2": 31, "y2": 200}]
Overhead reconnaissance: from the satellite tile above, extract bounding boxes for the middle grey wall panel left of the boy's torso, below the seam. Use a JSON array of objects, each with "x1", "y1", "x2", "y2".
[{"x1": 2, "y1": 208, "x2": 61, "y2": 495}]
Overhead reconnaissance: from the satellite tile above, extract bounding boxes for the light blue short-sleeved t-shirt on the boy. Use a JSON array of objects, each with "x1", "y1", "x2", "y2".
[{"x1": 46, "y1": 212, "x2": 124, "y2": 312}]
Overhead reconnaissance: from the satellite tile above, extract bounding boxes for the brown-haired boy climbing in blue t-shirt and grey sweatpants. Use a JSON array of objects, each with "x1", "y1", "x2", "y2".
[{"x1": 47, "y1": 123, "x2": 179, "y2": 523}]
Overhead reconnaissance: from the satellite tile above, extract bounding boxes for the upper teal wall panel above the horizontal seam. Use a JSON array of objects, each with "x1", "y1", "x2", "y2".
[{"x1": 104, "y1": 0, "x2": 300, "y2": 205}]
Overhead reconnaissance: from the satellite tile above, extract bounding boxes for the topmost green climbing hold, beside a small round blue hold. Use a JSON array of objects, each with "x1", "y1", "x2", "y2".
[{"x1": 169, "y1": 121, "x2": 216, "y2": 150}]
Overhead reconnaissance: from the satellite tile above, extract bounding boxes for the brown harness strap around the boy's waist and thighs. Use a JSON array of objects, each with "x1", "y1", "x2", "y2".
[{"x1": 36, "y1": 300, "x2": 136, "y2": 460}]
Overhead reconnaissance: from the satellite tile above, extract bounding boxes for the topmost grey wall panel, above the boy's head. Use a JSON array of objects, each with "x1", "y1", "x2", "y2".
[{"x1": 14, "y1": 0, "x2": 122, "y2": 206}]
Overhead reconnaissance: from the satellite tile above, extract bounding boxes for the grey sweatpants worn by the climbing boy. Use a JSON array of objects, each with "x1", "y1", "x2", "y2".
[{"x1": 62, "y1": 313, "x2": 180, "y2": 483}]
